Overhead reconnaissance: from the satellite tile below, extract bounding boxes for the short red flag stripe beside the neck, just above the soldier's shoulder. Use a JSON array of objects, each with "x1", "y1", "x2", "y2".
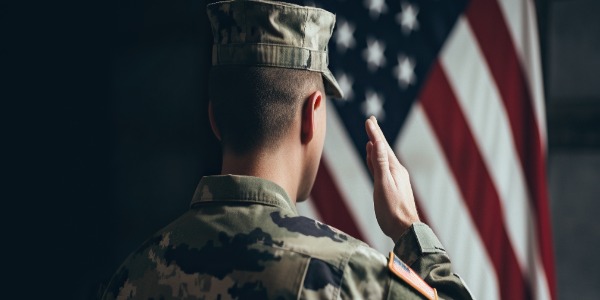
[{"x1": 311, "y1": 158, "x2": 364, "y2": 241}]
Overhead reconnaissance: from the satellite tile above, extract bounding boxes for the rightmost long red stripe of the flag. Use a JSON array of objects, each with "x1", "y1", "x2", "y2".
[{"x1": 466, "y1": 0, "x2": 556, "y2": 299}]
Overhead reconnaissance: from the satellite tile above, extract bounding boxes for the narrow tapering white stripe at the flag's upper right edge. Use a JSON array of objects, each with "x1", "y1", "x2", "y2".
[{"x1": 498, "y1": 0, "x2": 547, "y2": 151}]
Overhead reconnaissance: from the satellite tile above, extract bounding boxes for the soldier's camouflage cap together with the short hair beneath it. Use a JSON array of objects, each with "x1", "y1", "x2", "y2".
[{"x1": 207, "y1": 0, "x2": 342, "y2": 154}]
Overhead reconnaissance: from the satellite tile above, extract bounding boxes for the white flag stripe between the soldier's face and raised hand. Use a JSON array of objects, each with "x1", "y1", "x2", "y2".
[{"x1": 323, "y1": 100, "x2": 394, "y2": 253}]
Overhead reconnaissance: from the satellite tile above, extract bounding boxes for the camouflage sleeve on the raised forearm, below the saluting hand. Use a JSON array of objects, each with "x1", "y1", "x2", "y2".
[{"x1": 394, "y1": 223, "x2": 473, "y2": 299}]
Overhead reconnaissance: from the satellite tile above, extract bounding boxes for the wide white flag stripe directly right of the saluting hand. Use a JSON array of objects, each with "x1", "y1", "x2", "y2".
[{"x1": 394, "y1": 103, "x2": 500, "y2": 299}]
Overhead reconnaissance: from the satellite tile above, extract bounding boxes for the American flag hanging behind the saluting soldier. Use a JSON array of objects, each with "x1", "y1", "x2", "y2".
[{"x1": 296, "y1": 0, "x2": 556, "y2": 299}]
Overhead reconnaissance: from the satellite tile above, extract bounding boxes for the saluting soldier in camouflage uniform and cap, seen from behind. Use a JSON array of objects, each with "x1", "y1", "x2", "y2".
[{"x1": 103, "y1": 0, "x2": 472, "y2": 299}]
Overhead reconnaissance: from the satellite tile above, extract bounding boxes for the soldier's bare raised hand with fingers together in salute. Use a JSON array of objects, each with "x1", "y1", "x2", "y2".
[{"x1": 365, "y1": 116, "x2": 419, "y2": 242}]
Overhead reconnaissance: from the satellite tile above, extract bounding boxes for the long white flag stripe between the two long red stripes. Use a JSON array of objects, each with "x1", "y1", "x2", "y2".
[{"x1": 440, "y1": 18, "x2": 543, "y2": 293}]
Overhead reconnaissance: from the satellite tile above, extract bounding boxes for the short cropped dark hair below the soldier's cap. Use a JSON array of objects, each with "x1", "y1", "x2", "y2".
[{"x1": 209, "y1": 65, "x2": 324, "y2": 154}]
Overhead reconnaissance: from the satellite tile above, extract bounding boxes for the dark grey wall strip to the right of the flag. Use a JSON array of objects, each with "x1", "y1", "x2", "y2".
[{"x1": 541, "y1": 0, "x2": 600, "y2": 299}]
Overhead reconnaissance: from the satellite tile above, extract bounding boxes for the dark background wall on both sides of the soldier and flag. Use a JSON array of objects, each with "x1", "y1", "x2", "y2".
[{"x1": 0, "y1": 0, "x2": 600, "y2": 299}]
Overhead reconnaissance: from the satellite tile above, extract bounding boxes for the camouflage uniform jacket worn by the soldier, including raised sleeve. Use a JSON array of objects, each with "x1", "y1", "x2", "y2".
[{"x1": 103, "y1": 175, "x2": 471, "y2": 299}]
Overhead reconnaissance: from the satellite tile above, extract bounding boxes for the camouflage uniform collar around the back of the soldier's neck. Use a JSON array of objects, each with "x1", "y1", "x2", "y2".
[{"x1": 190, "y1": 175, "x2": 298, "y2": 215}]
